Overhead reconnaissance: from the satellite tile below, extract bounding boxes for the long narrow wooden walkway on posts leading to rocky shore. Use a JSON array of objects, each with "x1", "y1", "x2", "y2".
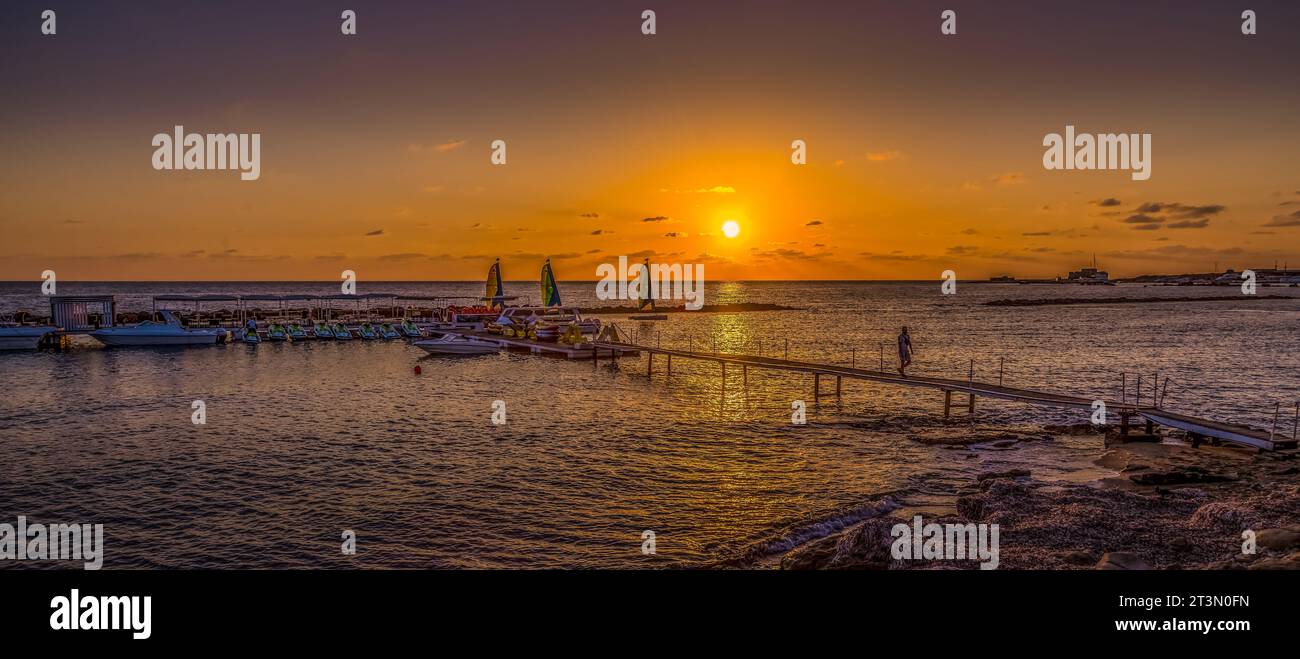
[{"x1": 594, "y1": 341, "x2": 1300, "y2": 451}]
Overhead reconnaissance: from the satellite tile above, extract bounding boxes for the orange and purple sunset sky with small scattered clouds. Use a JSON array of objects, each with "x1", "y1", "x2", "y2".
[{"x1": 0, "y1": 0, "x2": 1300, "y2": 281}]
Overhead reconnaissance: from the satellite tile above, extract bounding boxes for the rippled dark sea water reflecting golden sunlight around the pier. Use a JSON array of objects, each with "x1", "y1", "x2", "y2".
[{"x1": 0, "y1": 282, "x2": 1300, "y2": 568}]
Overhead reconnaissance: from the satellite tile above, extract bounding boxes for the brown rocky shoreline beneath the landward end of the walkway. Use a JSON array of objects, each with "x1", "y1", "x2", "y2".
[{"x1": 764, "y1": 429, "x2": 1300, "y2": 569}]
